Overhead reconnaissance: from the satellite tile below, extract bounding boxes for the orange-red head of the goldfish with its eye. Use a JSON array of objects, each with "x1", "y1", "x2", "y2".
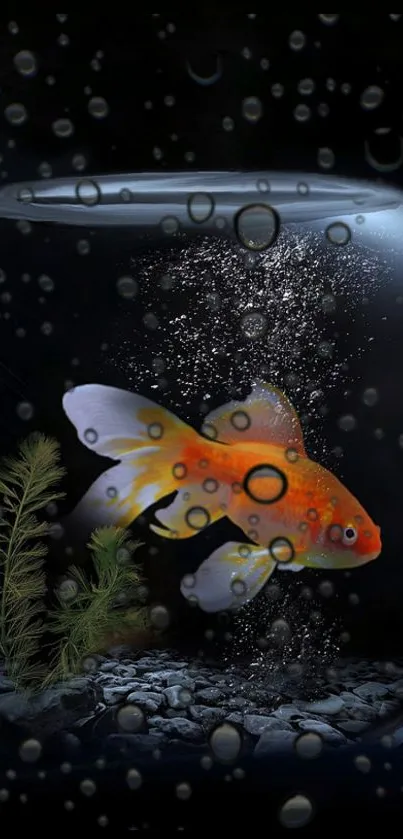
[{"x1": 302, "y1": 476, "x2": 382, "y2": 570}]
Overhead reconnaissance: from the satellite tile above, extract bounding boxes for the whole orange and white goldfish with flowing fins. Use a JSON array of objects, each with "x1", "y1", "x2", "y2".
[{"x1": 63, "y1": 380, "x2": 381, "y2": 612}]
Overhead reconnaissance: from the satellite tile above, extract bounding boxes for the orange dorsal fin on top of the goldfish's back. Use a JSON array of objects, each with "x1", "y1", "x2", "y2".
[{"x1": 202, "y1": 379, "x2": 306, "y2": 457}]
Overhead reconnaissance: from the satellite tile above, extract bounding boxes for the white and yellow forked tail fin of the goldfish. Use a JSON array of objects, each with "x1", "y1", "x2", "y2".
[{"x1": 63, "y1": 384, "x2": 198, "y2": 531}]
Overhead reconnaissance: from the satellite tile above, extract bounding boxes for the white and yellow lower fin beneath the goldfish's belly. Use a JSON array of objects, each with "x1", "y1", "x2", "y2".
[{"x1": 181, "y1": 542, "x2": 277, "y2": 612}]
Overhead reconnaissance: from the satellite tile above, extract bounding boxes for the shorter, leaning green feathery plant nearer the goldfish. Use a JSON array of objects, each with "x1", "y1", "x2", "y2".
[{"x1": 45, "y1": 526, "x2": 148, "y2": 682}]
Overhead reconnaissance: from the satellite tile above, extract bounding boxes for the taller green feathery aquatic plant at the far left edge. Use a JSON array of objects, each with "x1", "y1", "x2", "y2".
[{"x1": 0, "y1": 434, "x2": 64, "y2": 690}]
